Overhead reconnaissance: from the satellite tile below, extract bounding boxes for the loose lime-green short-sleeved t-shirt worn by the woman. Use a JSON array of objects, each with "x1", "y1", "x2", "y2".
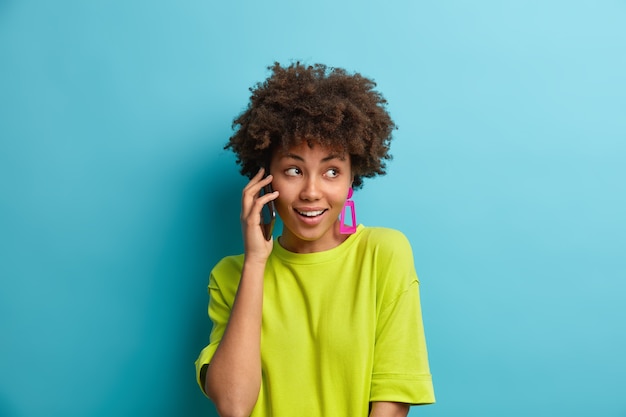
[{"x1": 196, "y1": 225, "x2": 435, "y2": 417}]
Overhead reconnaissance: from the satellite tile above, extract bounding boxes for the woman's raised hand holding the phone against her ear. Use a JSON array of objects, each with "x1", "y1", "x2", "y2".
[{"x1": 241, "y1": 168, "x2": 278, "y2": 262}]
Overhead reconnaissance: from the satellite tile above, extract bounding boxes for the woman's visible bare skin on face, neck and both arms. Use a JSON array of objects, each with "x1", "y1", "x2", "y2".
[{"x1": 205, "y1": 145, "x2": 409, "y2": 417}]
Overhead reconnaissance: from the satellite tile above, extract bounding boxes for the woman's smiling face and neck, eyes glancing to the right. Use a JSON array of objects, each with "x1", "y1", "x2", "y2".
[{"x1": 270, "y1": 142, "x2": 353, "y2": 253}]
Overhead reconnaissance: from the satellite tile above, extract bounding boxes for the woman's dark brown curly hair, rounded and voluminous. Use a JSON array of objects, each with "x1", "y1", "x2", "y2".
[{"x1": 224, "y1": 62, "x2": 396, "y2": 188}]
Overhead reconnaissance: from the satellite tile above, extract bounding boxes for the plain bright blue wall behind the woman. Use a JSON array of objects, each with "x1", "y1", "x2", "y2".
[{"x1": 0, "y1": 0, "x2": 626, "y2": 417}]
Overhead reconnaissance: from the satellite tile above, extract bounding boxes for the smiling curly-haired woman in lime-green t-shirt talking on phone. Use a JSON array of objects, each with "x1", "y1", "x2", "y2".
[{"x1": 196, "y1": 63, "x2": 434, "y2": 417}]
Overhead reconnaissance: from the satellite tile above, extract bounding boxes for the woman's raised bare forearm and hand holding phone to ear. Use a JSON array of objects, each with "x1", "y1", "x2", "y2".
[{"x1": 204, "y1": 170, "x2": 278, "y2": 417}]
